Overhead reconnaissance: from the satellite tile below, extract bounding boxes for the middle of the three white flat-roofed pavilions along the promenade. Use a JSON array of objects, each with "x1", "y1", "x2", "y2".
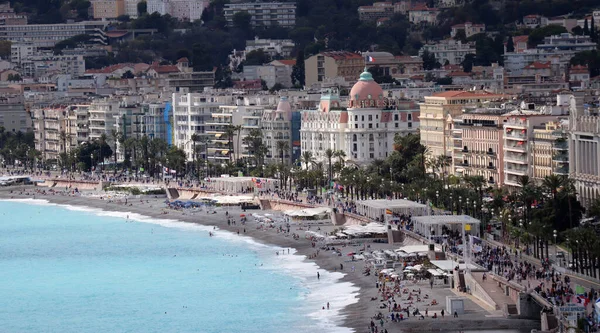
[{"x1": 356, "y1": 199, "x2": 428, "y2": 221}]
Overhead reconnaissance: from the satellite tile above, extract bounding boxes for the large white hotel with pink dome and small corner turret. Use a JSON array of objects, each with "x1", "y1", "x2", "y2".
[{"x1": 300, "y1": 71, "x2": 418, "y2": 164}]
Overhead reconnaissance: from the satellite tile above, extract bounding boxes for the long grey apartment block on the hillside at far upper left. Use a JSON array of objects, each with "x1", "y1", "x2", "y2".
[{"x1": 0, "y1": 21, "x2": 108, "y2": 48}]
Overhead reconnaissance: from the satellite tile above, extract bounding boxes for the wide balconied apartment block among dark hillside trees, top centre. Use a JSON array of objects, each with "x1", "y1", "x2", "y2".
[{"x1": 223, "y1": 2, "x2": 296, "y2": 28}]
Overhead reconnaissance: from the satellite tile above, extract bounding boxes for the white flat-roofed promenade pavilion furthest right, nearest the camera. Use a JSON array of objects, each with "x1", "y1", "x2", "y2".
[{"x1": 412, "y1": 215, "x2": 481, "y2": 239}]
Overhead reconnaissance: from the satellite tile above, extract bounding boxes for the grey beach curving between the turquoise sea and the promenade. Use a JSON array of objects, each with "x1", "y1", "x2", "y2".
[{"x1": 0, "y1": 186, "x2": 539, "y2": 333}]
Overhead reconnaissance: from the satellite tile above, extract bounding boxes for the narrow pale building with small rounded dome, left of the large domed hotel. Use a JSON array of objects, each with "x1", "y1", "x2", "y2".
[{"x1": 261, "y1": 97, "x2": 292, "y2": 163}]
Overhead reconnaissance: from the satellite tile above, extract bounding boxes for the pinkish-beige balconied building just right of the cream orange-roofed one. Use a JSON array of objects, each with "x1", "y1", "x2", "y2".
[{"x1": 451, "y1": 108, "x2": 506, "y2": 186}]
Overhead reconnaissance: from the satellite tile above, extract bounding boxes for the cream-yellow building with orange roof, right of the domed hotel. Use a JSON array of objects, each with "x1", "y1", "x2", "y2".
[{"x1": 420, "y1": 91, "x2": 505, "y2": 157}]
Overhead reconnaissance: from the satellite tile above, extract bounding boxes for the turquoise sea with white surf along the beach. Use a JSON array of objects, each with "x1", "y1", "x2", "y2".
[{"x1": 0, "y1": 199, "x2": 359, "y2": 333}]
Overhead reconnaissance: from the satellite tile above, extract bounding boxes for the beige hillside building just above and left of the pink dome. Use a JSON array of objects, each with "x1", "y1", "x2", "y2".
[{"x1": 304, "y1": 51, "x2": 365, "y2": 87}]
